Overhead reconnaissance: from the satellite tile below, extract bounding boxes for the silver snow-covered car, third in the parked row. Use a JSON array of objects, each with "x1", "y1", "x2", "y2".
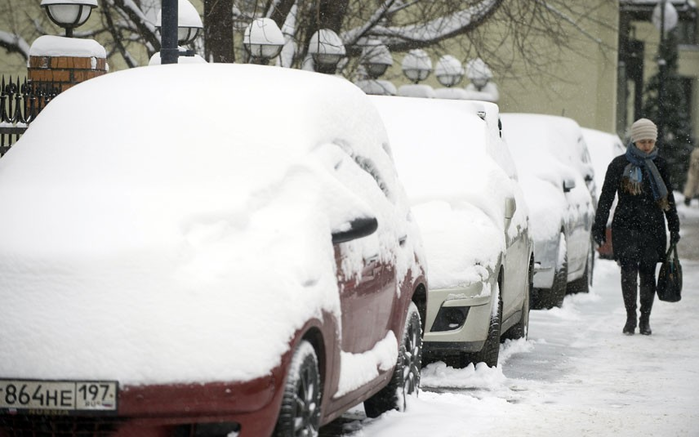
[{"x1": 501, "y1": 113, "x2": 596, "y2": 308}]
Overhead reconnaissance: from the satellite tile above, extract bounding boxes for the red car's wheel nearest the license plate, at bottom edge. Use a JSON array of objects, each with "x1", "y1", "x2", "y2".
[{"x1": 274, "y1": 340, "x2": 320, "y2": 437}]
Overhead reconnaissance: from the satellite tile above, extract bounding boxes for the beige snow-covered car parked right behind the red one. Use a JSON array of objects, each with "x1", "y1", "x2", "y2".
[{"x1": 372, "y1": 96, "x2": 534, "y2": 367}]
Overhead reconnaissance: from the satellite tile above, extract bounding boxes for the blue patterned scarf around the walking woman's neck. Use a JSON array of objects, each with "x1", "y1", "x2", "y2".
[{"x1": 622, "y1": 143, "x2": 670, "y2": 211}]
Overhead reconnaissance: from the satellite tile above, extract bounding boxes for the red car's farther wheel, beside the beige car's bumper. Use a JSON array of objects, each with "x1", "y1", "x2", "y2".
[{"x1": 364, "y1": 302, "x2": 422, "y2": 418}]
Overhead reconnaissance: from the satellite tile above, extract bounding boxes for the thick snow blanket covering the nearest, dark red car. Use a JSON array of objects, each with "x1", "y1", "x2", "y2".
[{"x1": 0, "y1": 64, "x2": 420, "y2": 385}]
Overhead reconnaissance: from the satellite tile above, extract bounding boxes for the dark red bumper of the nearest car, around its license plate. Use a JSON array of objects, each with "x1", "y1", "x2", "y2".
[{"x1": 0, "y1": 372, "x2": 283, "y2": 437}]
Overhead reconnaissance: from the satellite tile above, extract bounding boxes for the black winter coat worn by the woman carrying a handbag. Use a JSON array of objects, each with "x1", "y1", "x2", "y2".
[{"x1": 593, "y1": 152, "x2": 680, "y2": 264}]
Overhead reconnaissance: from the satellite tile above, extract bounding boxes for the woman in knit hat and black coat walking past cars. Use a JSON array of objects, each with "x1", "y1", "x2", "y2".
[{"x1": 592, "y1": 118, "x2": 680, "y2": 335}]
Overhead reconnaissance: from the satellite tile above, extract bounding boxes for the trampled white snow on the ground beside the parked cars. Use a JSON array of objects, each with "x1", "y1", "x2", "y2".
[{"x1": 344, "y1": 240, "x2": 699, "y2": 437}]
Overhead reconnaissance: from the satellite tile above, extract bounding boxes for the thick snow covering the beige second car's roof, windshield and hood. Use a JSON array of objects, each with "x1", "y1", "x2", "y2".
[{"x1": 372, "y1": 96, "x2": 526, "y2": 288}]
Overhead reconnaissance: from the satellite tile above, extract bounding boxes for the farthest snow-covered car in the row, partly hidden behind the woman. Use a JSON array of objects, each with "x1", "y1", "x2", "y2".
[{"x1": 582, "y1": 128, "x2": 626, "y2": 259}]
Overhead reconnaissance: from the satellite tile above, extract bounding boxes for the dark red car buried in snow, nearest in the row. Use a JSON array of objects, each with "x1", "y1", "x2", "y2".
[{"x1": 0, "y1": 64, "x2": 426, "y2": 437}]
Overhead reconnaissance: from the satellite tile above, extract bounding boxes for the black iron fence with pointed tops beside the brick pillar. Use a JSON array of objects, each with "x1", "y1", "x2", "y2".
[{"x1": 0, "y1": 76, "x2": 60, "y2": 157}]
